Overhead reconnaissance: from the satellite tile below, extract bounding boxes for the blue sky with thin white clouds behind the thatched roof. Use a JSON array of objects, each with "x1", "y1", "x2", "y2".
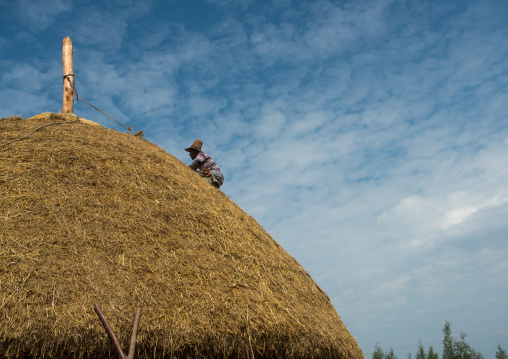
[{"x1": 0, "y1": 0, "x2": 508, "y2": 359}]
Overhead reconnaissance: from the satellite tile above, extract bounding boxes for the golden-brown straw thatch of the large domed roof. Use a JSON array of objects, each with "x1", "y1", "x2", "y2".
[{"x1": 0, "y1": 113, "x2": 363, "y2": 359}]
